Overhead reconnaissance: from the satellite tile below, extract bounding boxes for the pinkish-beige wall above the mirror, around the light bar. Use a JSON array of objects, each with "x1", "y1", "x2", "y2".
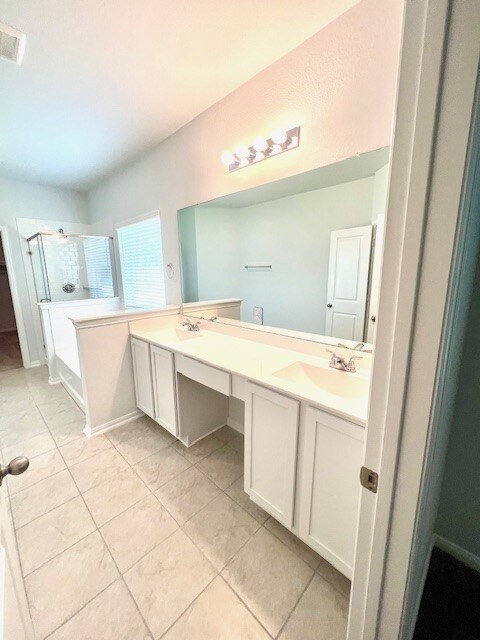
[{"x1": 88, "y1": 0, "x2": 403, "y2": 303}]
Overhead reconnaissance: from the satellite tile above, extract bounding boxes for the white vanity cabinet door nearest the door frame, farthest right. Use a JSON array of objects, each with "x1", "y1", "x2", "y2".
[{"x1": 299, "y1": 407, "x2": 364, "y2": 579}]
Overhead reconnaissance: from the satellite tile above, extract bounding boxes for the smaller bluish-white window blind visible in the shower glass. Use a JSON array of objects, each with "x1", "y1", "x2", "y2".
[{"x1": 83, "y1": 237, "x2": 115, "y2": 298}]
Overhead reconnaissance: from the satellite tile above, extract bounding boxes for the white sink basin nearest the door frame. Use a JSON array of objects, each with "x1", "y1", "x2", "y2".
[{"x1": 273, "y1": 361, "x2": 368, "y2": 398}]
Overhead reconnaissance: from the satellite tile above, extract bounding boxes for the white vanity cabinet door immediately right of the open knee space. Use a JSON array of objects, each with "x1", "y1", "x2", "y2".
[{"x1": 245, "y1": 382, "x2": 299, "y2": 529}]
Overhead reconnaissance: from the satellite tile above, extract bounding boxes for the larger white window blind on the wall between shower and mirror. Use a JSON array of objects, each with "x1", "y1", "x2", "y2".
[{"x1": 117, "y1": 216, "x2": 166, "y2": 309}]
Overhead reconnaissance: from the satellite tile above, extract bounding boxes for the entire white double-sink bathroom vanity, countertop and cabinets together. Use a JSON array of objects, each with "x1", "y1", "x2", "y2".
[{"x1": 131, "y1": 316, "x2": 369, "y2": 578}]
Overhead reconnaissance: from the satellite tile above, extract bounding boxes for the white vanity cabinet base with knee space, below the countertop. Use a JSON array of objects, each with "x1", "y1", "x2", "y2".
[{"x1": 131, "y1": 337, "x2": 364, "y2": 578}]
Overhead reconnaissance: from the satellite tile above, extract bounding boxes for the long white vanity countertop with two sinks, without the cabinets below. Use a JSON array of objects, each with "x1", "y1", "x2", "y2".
[{"x1": 131, "y1": 328, "x2": 370, "y2": 426}]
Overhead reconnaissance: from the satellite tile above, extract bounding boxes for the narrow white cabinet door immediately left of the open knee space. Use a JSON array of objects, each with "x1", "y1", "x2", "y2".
[{"x1": 151, "y1": 346, "x2": 178, "y2": 436}]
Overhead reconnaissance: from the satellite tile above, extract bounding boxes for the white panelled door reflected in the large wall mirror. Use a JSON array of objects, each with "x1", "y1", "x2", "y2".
[{"x1": 325, "y1": 225, "x2": 373, "y2": 342}]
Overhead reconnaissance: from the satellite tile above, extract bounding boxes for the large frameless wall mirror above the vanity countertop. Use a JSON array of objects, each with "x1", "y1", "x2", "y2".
[{"x1": 178, "y1": 148, "x2": 389, "y2": 343}]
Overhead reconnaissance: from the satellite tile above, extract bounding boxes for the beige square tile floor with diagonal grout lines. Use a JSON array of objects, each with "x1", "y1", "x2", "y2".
[{"x1": 0, "y1": 368, "x2": 350, "y2": 640}]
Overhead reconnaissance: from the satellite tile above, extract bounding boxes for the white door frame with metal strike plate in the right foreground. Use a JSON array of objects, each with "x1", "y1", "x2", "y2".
[{"x1": 348, "y1": 0, "x2": 480, "y2": 640}]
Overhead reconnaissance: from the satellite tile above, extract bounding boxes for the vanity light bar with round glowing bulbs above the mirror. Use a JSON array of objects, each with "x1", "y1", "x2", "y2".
[{"x1": 221, "y1": 127, "x2": 300, "y2": 173}]
